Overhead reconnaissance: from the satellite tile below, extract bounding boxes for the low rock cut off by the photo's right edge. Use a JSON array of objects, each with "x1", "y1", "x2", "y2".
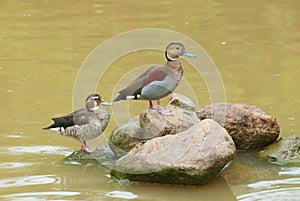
[{"x1": 258, "y1": 135, "x2": 300, "y2": 164}]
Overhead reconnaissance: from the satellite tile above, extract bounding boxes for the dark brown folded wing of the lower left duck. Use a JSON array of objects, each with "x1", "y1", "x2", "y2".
[{"x1": 44, "y1": 109, "x2": 89, "y2": 129}]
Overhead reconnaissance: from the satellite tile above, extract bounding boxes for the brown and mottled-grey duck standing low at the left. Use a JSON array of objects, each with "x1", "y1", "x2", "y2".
[{"x1": 43, "y1": 93, "x2": 112, "y2": 153}]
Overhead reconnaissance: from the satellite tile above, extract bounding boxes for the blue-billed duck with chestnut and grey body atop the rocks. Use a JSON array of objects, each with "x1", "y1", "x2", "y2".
[{"x1": 113, "y1": 42, "x2": 196, "y2": 115}]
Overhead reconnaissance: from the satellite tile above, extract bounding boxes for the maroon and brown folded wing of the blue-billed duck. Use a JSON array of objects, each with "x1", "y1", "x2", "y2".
[{"x1": 114, "y1": 65, "x2": 169, "y2": 101}]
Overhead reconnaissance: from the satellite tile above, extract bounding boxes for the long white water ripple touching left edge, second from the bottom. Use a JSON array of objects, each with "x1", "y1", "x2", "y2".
[{"x1": 0, "y1": 175, "x2": 59, "y2": 189}]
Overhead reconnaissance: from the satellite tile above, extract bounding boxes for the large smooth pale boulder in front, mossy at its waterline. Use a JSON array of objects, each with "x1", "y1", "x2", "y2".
[{"x1": 111, "y1": 119, "x2": 235, "y2": 185}]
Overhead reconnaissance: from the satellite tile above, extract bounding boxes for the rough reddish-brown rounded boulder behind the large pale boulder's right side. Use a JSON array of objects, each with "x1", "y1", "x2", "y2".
[{"x1": 197, "y1": 103, "x2": 280, "y2": 150}]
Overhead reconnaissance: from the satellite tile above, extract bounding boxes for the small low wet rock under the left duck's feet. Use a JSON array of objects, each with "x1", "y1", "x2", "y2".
[{"x1": 64, "y1": 145, "x2": 115, "y2": 165}]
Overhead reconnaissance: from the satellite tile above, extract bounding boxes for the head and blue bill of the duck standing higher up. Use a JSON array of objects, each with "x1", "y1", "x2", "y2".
[{"x1": 165, "y1": 43, "x2": 196, "y2": 61}]
